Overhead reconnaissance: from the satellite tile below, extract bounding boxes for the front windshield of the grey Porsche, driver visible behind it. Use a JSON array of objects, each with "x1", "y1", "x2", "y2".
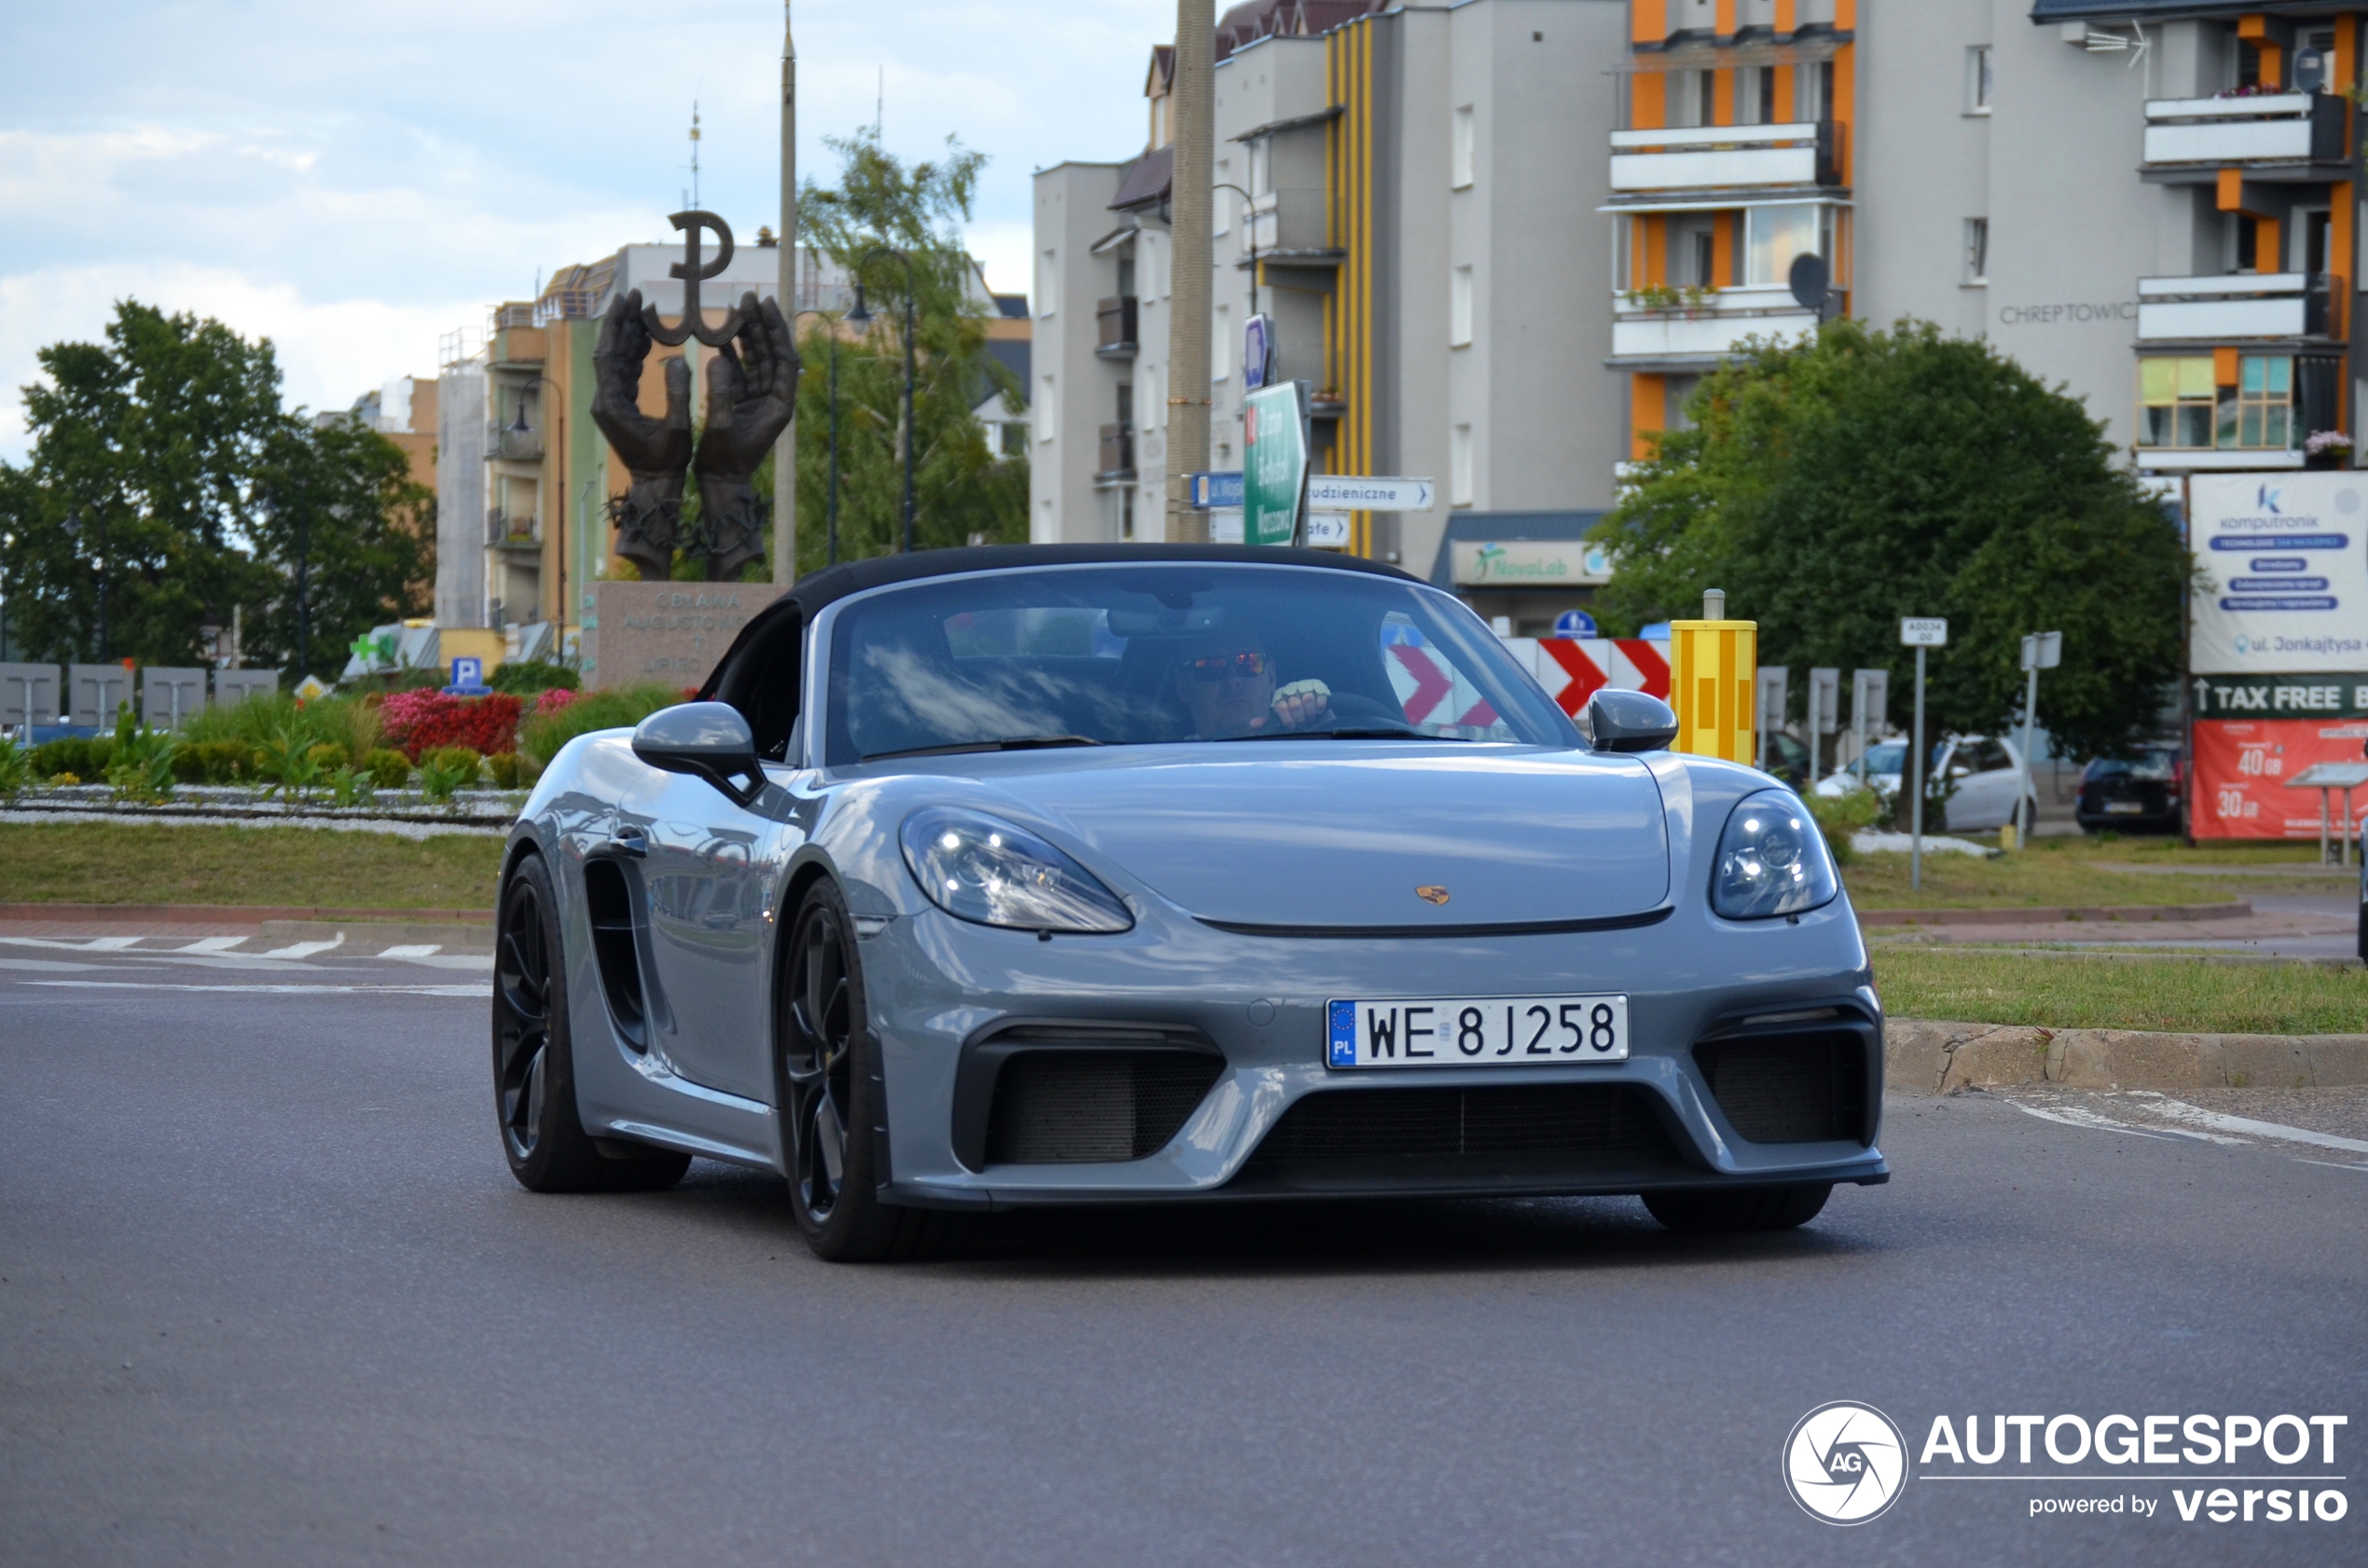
[{"x1": 826, "y1": 561, "x2": 1582, "y2": 765}]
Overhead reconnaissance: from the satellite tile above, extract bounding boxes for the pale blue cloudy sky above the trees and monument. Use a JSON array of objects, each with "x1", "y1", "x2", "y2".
[{"x1": 0, "y1": 0, "x2": 1175, "y2": 461}]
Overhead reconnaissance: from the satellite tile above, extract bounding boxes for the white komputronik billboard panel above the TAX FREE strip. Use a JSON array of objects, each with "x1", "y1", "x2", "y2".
[{"x1": 2188, "y1": 472, "x2": 2368, "y2": 675}]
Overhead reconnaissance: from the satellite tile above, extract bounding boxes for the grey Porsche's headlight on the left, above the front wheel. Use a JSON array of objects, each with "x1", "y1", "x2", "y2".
[{"x1": 898, "y1": 807, "x2": 1135, "y2": 931}]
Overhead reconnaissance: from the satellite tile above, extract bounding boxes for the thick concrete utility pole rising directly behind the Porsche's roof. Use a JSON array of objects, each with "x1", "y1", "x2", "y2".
[{"x1": 1167, "y1": 0, "x2": 1218, "y2": 543}]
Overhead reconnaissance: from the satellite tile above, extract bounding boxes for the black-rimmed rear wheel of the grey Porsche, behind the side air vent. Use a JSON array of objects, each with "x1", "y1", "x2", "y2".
[{"x1": 492, "y1": 855, "x2": 692, "y2": 1191}]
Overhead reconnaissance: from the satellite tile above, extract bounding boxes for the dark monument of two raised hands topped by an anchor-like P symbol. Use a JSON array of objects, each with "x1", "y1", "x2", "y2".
[{"x1": 592, "y1": 211, "x2": 798, "y2": 583}]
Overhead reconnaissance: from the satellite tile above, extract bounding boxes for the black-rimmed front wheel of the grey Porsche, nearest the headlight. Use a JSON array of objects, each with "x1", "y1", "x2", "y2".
[{"x1": 775, "y1": 881, "x2": 961, "y2": 1262}]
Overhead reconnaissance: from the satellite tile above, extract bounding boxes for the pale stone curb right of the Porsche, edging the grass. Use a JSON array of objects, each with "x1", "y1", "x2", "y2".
[{"x1": 1882, "y1": 1019, "x2": 2368, "y2": 1094}]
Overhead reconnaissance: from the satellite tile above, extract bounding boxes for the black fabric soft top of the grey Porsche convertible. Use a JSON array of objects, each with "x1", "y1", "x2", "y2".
[{"x1": 698, "y1": 544, "x2": 1421, "y2": 756}]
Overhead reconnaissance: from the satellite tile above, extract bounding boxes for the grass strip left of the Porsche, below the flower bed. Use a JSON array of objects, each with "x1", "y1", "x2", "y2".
[{"x1": 0, "y1": 822, "x2": 502, "y2": 910}]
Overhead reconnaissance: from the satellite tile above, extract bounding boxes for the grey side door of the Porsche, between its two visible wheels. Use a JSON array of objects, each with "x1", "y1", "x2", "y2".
[{"x1": 615, "y1": 770, "x2": 795, "y2": 1101}]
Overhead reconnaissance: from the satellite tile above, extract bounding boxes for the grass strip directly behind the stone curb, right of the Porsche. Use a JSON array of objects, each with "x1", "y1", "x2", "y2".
[{"x1": 1873, "y1": 947, "x2": 2368, "y2": 1035}]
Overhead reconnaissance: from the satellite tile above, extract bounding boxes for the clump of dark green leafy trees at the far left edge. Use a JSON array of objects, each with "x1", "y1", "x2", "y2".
[{"x1": 0, "y1": 301, "x2": 434, "y2": 675}]
